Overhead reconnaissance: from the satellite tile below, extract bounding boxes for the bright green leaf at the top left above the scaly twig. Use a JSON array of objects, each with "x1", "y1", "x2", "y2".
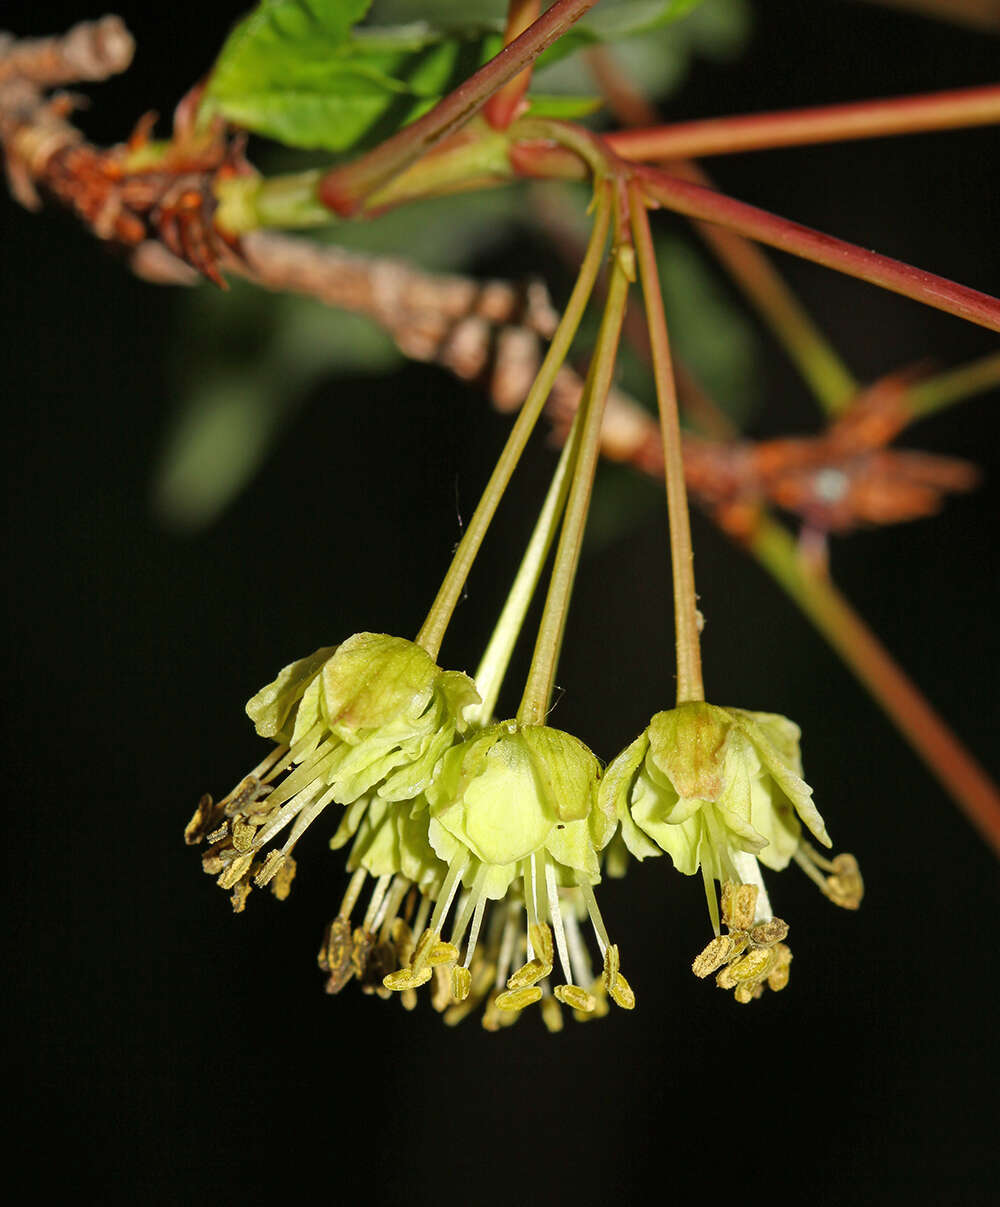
[{"x1": 201, "y1": 0, "x2": 499, "y2": 151}]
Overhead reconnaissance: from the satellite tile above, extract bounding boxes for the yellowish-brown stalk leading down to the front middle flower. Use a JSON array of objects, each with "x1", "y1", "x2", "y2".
[{"x1": 517, "y1": 185, "x2": 634, "y2": 725}]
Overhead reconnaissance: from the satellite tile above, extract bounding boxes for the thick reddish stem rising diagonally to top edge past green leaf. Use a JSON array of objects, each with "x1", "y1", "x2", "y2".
[{"x1": 320, "y1": 0, "x2": 597, "y2": 217}]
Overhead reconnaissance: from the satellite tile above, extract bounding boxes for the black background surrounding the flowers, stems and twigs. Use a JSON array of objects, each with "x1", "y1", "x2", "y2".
[{"x1": 0, "y1": 0, "x2": 1000, "y2": 1205}]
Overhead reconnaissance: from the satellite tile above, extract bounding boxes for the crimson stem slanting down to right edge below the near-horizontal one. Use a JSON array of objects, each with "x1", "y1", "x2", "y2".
[{"x1": 633, "y1": 165, "x2": 1000, "y2": 331}]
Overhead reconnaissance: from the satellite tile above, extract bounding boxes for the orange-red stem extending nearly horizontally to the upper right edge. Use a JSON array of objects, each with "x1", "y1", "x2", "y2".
[{"x1": 606, "y1": 84, "x2": 1000, "y2": 161}]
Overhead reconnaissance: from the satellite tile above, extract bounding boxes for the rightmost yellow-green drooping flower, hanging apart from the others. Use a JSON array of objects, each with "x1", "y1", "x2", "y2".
[{"x1": 601, "y1": 701, "x2": 861, "y2": 1001}]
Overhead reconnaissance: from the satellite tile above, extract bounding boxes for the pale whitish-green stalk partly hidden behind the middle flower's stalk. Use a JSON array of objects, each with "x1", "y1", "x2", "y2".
[{"x1": 468, "y1": 410, "x2": 581, "y2": 725}]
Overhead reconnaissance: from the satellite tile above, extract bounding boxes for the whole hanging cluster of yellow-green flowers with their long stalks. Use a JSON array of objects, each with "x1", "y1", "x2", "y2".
[{"x1": 186, "y1": 181, "x2": 862, "y2": 1031}]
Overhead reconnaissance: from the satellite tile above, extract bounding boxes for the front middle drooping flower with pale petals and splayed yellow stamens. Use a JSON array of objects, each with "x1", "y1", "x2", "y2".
[{"x1": 384, "y1": 721, "x2": 634, "y2": 1028}]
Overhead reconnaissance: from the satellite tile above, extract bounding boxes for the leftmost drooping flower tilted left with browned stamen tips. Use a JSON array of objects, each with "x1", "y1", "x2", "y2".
[{"x1": 185, "y1": 632, "x2": 479, "y2": 910}]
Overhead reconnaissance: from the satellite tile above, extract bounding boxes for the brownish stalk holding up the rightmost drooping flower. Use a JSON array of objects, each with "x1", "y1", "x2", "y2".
[{"x1": 628, "y1": 182, "x2": 704, "y2": 704}]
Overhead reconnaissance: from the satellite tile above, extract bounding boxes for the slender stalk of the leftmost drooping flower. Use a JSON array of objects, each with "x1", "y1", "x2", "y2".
[{"x1": 416, "y1": 189, "x2": 610, "y2": 658}]
